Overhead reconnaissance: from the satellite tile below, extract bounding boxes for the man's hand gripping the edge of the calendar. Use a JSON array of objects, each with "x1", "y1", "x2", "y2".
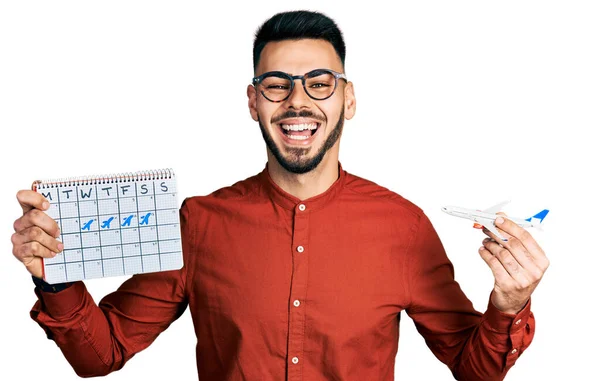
[{"x1": 11, "y1": 190, "x2": 63, "y2": 279}]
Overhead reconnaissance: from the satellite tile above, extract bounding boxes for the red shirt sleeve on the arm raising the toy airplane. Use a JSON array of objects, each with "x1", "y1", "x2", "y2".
[{"x1": 404, "y1": 215, "x2": 535, "y2": 381}]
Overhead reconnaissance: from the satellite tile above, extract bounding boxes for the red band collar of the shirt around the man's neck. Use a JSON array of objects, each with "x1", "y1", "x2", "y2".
[{"x1": 259, "y1": 160, "x2": 347, "y2": 210}]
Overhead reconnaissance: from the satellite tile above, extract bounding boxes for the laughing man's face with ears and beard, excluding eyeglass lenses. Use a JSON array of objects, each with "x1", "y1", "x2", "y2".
[{"x1": 247, "y1": 39, "x2": 355, "y2": 173}]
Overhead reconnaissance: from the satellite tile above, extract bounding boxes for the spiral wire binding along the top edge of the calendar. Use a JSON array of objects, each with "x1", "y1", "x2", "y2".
[{"x1": 33, "y1": 168, "x2": 175, "y2": 189}]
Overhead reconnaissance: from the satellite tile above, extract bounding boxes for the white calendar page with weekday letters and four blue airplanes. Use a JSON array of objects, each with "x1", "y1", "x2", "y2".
[{"x1": 37, "y1": 172, "x2": 183, "y2": 284}]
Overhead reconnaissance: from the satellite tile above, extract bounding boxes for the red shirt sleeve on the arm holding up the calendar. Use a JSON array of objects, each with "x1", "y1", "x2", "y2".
[{"x1": 30, "y1": 197, "x2": 190, "y2": 377}]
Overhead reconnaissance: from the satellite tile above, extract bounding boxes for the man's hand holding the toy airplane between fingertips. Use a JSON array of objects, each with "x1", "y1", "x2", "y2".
[{"x1": 479, "y1": 215, "x2": 550, "y2": 314}]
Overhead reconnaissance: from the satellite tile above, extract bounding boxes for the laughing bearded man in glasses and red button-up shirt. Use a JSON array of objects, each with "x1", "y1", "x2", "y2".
[{"x1": 12, "y1": 11, "x2": 548, "y2": 381}]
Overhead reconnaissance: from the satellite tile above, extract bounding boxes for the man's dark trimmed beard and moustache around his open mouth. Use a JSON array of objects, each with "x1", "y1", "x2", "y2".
[{"x1": 258, "y1": 106, "x2": 344, "y2": 174}]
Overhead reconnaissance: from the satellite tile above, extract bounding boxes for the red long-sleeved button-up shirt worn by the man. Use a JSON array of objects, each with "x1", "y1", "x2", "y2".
[{"x1": 31, "y1": 162, "x2": 534, "y2": 381}]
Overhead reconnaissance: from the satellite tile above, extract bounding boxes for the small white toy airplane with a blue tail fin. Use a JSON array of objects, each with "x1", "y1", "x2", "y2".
[{"x1": 442, "y1": 201, "x2": 548, "y2": 241}]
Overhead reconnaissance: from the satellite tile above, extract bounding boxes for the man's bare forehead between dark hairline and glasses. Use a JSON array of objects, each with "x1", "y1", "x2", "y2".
[{"x1": 256, "y1": 39, "x2": 344, "y2": 75}]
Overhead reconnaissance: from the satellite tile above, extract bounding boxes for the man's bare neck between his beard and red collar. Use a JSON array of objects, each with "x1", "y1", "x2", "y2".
[{"x1": 267, "y1": 153, "x2": 339, "y2": 200}]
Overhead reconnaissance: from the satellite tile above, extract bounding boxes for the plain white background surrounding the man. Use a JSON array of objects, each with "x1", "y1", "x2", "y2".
[{"x1": 0, "y1": 1, "x2": 600, "y2": 381}]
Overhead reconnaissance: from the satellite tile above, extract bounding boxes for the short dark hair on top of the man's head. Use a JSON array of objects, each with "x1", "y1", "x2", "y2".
[{"x1": 252, "y1": 11, "x2": 346, "y2": 70}]
